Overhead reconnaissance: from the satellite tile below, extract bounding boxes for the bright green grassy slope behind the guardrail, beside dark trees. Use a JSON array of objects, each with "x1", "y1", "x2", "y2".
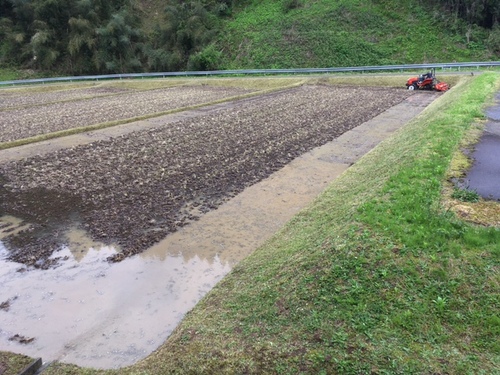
[{"x1": 217, "y1": 0, "x2": 490, "y2": 69}]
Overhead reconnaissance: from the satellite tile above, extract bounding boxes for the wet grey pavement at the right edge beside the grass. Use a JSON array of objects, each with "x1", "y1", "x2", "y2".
[{"x1": 459, "y1": 94, "x2": 500, "y2": 200}]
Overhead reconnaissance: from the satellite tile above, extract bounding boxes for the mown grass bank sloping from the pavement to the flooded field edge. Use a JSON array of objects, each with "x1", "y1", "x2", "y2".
[{"x1": 40, "y1": 74, "x2": 500, "y2": 375}]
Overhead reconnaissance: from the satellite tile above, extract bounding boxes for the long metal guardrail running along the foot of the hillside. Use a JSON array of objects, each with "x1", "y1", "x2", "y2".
[{"x1": 0, "y1": 61, "x2": 500, "y2": 86}]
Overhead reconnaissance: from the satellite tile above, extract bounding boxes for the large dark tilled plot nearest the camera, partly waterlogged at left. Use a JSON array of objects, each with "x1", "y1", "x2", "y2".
[{"x1": 0, "y1": 86, "x2": 411, "y2": 268}]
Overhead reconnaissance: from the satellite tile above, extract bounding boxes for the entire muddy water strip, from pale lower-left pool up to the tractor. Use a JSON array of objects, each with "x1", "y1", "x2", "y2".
[{"x1": 0, "y1": 93, "x2": 435, "y2": 368}]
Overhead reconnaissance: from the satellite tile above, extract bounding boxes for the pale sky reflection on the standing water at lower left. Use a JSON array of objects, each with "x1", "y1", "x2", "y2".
[{"x1": 0, "y1": 234, "x2": 230, "y2": 368}]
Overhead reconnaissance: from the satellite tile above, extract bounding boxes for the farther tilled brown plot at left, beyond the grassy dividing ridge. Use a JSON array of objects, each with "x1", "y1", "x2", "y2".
[{"x1": 0, "y1": 86, "x2": 249, "y2": 142}]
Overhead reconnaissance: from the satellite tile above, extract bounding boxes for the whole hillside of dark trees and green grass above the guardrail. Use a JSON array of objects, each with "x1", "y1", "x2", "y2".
[{"x1": 0, "y1": 0, "x2": 500, "y2": 78}]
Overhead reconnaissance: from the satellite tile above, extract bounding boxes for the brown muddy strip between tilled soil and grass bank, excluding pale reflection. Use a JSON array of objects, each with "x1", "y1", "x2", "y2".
[{"x1": 140, "y1": 92, "x2": 439, "y2": 265}]
